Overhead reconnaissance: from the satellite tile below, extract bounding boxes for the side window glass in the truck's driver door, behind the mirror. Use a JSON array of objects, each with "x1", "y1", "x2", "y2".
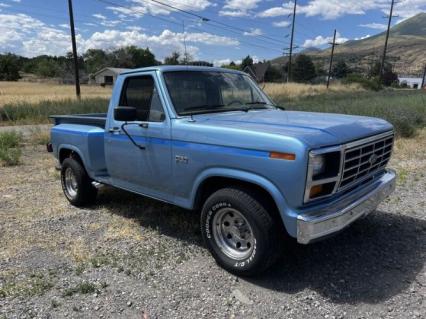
[{"x1": 120, "y1": 76, "x2": 165, "y2": 122}]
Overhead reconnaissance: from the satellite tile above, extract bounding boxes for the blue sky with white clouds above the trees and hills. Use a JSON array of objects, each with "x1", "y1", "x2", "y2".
[{"x1": 0, "y1": 0, "x2": 426, "y2": 65}]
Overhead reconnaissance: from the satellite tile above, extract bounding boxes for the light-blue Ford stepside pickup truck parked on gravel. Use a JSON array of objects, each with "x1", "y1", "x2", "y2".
[{"x1": 48, "y1": 66, "x2": 395, "y2": 275}]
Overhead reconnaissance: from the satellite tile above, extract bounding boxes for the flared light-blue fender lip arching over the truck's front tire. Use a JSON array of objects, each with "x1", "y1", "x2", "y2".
[{"x1": 190, "y1": 167, "x2": 297, "y2": 237}]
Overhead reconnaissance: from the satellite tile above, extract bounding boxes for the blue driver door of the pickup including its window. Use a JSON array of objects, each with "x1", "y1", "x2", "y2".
[{"x1": 105, "y1": 72, "x2": 171, "y2": 198}]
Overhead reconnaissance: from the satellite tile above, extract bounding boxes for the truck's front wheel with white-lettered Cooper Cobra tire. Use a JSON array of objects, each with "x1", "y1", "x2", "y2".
[{"x1": 201, "y1": 188, "x2": 279, "y2": 276}]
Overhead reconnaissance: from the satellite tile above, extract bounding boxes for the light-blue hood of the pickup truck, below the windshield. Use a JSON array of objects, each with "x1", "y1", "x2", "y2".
[{"x1": 194, "y1": 110, "x2": 393, "y2": 148}]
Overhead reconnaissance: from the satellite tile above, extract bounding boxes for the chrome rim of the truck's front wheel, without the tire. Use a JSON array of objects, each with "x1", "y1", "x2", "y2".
[{"x1": 212, "y1": 207, "x2": 256, "y2": 260}]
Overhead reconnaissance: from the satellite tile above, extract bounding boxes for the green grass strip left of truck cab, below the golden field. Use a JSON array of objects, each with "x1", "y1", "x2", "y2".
[{"x1": 0, "y1": 98, "x2": 109, "y2": 125}]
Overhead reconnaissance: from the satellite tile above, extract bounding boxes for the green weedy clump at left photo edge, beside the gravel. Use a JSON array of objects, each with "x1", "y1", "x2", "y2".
[{"x1": 0, "y1": 131, "x2": 22, "y2": 166}]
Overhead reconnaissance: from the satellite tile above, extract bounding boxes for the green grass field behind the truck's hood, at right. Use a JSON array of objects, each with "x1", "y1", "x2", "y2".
[{"x1": 274, "y1": 90, "x2": 426, "y2": 137}]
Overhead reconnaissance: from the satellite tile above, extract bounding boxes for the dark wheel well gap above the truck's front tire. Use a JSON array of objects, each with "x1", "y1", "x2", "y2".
[{"x1": 194, "y1": 177, "x2": 285, "y2": 229}]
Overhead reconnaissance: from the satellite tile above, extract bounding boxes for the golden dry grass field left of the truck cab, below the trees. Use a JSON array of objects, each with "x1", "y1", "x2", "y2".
[{"x1": 0, "y1": 81, "x2": 111, "y2": 107}]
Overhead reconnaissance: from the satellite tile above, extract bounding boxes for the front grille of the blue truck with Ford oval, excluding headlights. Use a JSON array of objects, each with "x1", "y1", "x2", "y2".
[{"x1": 339, "y1": 134, "x2": 394, "y2": 190}]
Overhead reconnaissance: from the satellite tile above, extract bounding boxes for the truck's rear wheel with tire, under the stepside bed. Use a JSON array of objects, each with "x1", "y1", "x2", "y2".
[{"x1": 61, "y1": 158, "x2": 98, "y2": 207}]
